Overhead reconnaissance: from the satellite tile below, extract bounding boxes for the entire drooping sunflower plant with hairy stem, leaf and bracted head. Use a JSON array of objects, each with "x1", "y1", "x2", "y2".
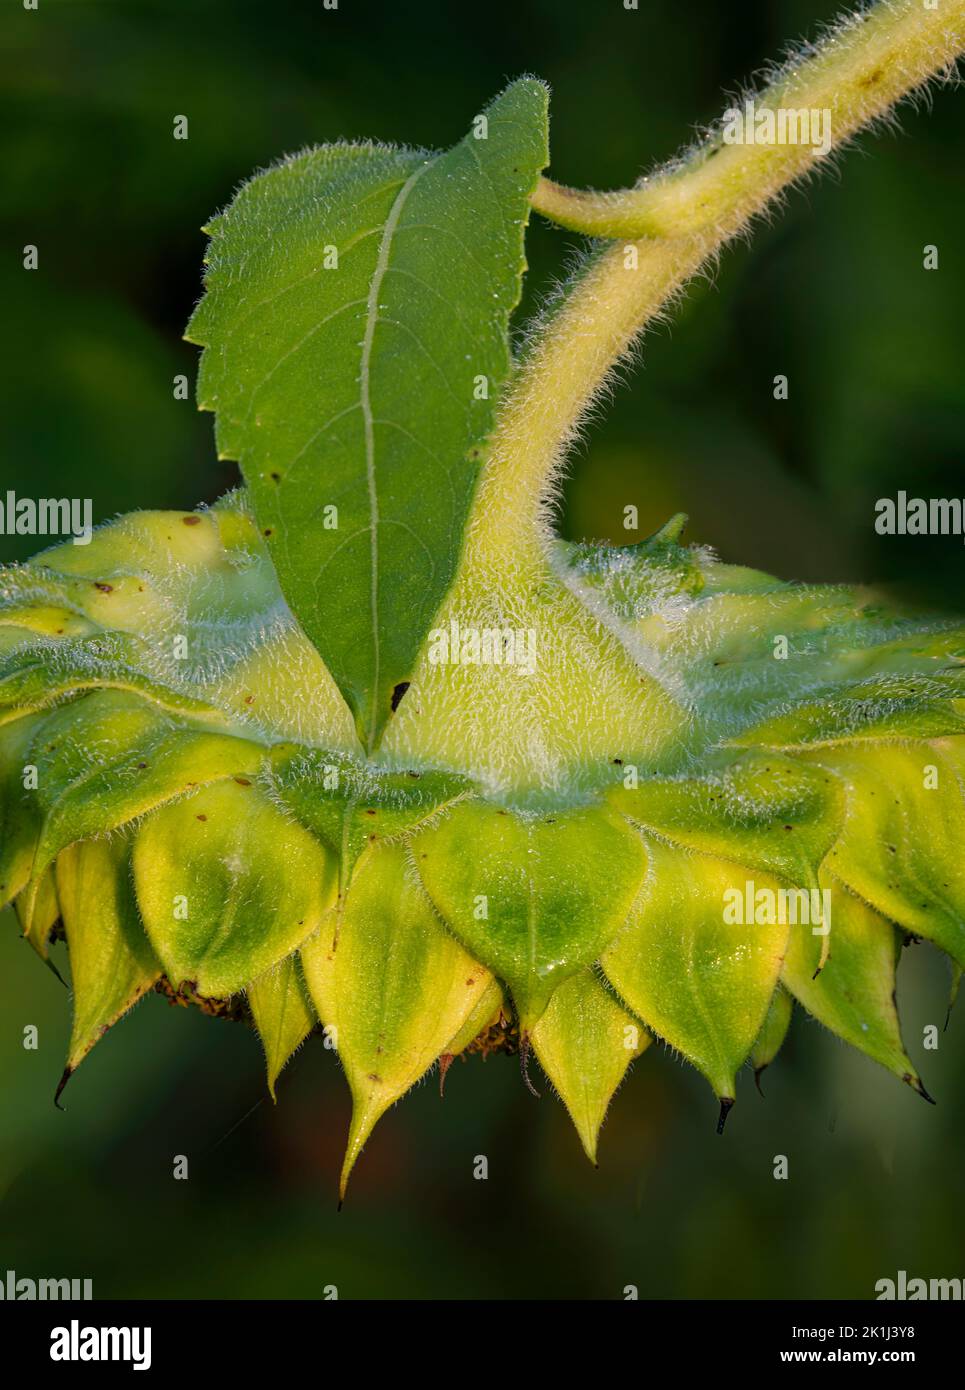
[{"x1": 0, "y1": 0, "x2": 965, "y2": 1187}]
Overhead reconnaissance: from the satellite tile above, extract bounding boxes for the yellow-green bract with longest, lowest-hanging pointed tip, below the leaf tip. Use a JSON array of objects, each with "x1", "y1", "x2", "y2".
[{"x1": 302, "y1": 845, "x2": 492, "y2": 1195}]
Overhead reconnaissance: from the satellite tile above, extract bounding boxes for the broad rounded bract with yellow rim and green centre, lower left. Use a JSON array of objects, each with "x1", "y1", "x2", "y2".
[{"x1": 133, "y1": 778, "x2": 335, "y2": 998}]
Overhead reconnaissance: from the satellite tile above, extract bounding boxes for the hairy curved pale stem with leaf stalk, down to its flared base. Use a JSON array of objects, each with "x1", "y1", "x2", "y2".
[{"x1": 463, "y1": 0, "x2": 965, "y2": 582}]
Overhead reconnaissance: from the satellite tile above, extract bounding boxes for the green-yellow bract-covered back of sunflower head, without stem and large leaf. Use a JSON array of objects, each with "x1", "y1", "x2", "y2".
[{"x1": 0, "y1": 495, "x2": 965, "y2": 1195}]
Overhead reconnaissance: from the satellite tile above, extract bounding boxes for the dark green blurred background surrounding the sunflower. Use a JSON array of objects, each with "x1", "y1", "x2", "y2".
[{"x1": 0, "y1": 0, "x2": 965, "y2": 1298}]
